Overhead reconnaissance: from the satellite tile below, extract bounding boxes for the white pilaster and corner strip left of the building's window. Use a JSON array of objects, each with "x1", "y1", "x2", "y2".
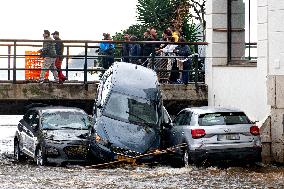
[{"x1": 205, "y1": 0, "x2": 228, "y2": 105}]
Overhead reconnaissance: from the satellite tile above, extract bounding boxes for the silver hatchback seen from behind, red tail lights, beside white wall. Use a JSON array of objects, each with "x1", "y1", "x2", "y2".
[{"x1": 165, "y1": 107, "x2": 261, "y2": 166}]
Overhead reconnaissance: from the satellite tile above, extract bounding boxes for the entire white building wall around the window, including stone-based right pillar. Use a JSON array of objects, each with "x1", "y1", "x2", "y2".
[{"x1": 206, "y1": 0, "x2": 284, "y2": 163}]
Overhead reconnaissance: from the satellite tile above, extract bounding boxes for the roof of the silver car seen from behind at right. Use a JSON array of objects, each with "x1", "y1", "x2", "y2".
[{"x1": 184, "y1": 106, "x2": 243, "y2": 114}]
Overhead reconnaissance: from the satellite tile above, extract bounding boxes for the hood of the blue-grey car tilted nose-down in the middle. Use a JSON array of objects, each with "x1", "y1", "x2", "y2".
[{"x1": 96, "y1": 117, "x2": 160, "y2": 153}]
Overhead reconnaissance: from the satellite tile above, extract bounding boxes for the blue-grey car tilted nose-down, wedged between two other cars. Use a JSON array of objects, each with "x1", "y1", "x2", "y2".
[{"x1": 90, "y1": 62, "x2": 169, "y2": 162}]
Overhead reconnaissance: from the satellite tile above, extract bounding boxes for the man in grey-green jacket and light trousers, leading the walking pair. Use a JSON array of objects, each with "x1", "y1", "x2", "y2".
[{"x1": 38, "y1": 30, "x2": 59, "y2": 83}]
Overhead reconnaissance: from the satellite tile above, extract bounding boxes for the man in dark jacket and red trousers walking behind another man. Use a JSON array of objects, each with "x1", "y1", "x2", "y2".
[{"x1": 51, "y1": 31, "x2": 67, "y2": 82}]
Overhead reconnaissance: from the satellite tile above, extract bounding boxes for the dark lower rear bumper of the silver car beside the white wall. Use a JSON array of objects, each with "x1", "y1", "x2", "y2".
[{"x1": 189, "y1": 147, "x2": 261, "y2": 161}]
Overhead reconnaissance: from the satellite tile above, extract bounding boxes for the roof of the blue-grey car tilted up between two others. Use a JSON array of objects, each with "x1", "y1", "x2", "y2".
[{"x1": 109, "y1": 62, "x2": 159, "y2": 99}]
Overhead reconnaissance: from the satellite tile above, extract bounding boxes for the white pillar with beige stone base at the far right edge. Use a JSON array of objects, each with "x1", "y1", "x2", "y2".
[{"x1": 266, "y1": 0, "x2": 284, "y2": 163}]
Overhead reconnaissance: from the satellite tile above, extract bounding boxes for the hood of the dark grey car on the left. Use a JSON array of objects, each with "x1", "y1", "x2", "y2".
[{"x1": 46, "y1": 129, "x2": 88, "y2": 141}]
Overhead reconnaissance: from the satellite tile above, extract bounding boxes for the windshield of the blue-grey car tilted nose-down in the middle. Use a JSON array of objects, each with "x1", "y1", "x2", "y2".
[{"x1": 104, "y1": 92, "x2": 158, "y2": 125}]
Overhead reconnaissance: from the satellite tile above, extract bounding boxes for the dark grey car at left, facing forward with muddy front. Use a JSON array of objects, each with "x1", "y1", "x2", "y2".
[{"x1": 14, "y1": 106, "x2": 92, "y2": 166}]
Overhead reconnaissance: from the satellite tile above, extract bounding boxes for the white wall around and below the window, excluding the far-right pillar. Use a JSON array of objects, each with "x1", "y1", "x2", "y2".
[{"x1": 205, "y1": 0, "x2": 270, "y2": 121}]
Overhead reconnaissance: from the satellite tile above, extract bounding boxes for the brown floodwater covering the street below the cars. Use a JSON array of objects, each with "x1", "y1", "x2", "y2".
[{"x1": 0, "y1": 126, "x2": 284, "y2": 189}]
